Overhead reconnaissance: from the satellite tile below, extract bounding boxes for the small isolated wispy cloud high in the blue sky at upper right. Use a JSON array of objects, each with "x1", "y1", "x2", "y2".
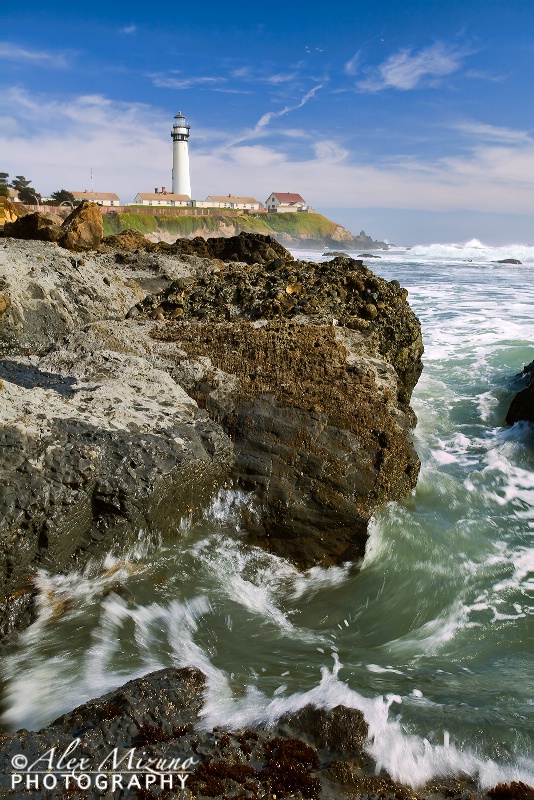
[{"x1": 360, "y1": 42, "x2": 468, "y2": 92}]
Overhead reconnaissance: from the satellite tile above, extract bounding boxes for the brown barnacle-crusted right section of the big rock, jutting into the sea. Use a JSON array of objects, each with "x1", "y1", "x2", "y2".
[{"x1": 135, "y1": 258, "x2": 422, "y2": 568}]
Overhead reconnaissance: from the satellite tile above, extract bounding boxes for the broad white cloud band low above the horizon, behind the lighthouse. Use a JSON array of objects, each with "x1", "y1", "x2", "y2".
[{"x1": 0, "y1": 89, "x2": 534, "y2": 215}]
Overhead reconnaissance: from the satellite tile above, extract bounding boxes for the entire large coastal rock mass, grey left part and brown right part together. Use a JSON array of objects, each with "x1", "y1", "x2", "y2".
[{"x1": 0, "y1": 234, "x2": 422, "y2": 630}]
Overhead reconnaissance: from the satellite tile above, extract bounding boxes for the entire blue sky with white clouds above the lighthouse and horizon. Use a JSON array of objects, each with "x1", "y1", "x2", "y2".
[{"x1": 0, "y1": 0, "x2": 534, "y2": 244}]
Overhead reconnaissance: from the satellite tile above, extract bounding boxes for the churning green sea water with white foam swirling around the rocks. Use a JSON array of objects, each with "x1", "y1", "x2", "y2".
[{"x1": 3, "y1": 241, "x2": 534, "y2": 787}]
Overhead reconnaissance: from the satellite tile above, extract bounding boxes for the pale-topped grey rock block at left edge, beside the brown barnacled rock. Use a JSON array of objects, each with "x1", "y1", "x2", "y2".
[{"x1": 0, "y1": 323, "x2": 233, "y2": 634}]
